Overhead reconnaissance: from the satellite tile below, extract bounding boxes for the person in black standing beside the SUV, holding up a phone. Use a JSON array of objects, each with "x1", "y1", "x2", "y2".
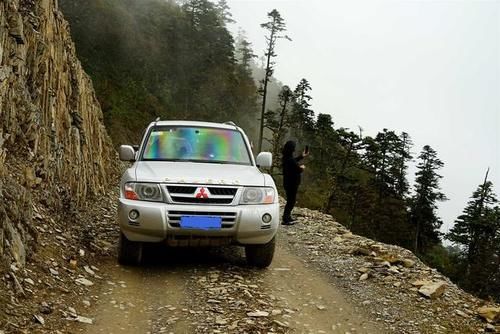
[{"x1": 281, "y1": 140, "x2": 309, "y2": 225}]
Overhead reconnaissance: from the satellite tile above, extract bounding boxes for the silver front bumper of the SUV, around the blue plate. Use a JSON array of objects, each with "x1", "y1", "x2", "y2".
[{"x1": 118, "y1": 198, "x2": 279, "y2": 246}]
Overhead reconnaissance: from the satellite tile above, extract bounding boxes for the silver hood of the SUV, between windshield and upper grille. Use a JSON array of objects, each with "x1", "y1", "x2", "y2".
[{"x1": 135, "y1": 161, "x2": 265, "y2": 186}]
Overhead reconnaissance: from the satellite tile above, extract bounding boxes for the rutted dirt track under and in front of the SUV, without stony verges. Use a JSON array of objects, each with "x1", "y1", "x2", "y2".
[{"x1": 80, "y1": 239, "x2": 384, "y2": 334}]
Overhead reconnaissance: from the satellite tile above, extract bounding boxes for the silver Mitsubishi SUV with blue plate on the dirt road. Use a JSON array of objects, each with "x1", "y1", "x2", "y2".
[{"x1": 118, "y1": 121, "x2": 279, "y2": 267}]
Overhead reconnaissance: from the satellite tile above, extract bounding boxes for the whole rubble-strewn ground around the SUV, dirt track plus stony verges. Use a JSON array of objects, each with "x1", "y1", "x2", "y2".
[{"x1": 0, "y1": 201, "x2": 491, "y2": 334}]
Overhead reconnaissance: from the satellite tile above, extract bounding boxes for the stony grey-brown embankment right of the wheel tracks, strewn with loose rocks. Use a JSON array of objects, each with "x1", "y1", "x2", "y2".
[{"x1": 282, "y1": 209, "x2": 500, "y2": 333}]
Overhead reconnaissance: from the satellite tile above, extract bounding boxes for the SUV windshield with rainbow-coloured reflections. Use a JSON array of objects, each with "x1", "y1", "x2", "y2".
[{"x1": 142, "y1": 126, "x2": 251, "y2": 165}]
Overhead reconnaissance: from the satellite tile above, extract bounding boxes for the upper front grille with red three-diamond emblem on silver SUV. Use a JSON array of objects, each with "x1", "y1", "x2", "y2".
[{"x1": 166, "y1": 185, "x2": 238, "y2": 205}]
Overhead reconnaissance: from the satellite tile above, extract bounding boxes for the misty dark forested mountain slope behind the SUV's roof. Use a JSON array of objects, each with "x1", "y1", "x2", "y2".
[{"x1": 59, "y1": 0, "x2": 258, "y2": 144}]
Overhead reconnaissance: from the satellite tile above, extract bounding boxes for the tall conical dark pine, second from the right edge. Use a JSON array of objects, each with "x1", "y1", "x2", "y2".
[{"x1": 410, "y1": 145, "x2": 446, "y2": 254}]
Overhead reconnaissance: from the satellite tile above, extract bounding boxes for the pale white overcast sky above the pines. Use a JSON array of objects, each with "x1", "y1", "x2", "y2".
[{"x1": 228, "y1": 0, "x2": 500, "y2": 231}]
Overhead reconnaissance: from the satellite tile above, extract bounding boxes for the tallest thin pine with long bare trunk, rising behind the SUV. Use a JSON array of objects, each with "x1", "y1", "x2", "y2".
[{"x1": 257, "y1": 9, "x2": 291, "y2": 152}]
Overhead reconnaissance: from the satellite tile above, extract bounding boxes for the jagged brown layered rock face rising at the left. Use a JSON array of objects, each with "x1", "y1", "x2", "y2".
[{"x1": 0, "y1": 0, "x2": 114, "y2": 265}]
